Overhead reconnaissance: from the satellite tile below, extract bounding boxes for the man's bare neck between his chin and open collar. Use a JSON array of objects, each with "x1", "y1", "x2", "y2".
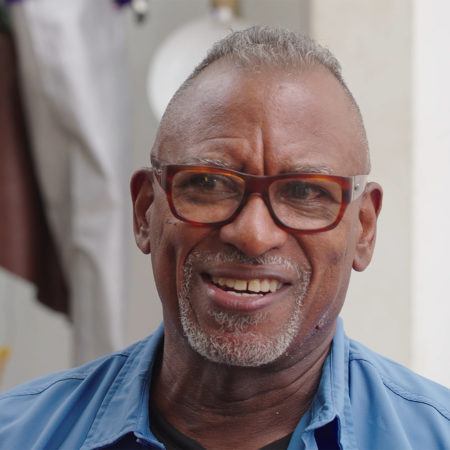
[{"x1": 152, "y1": 326, "x2": 334, "y2": 449}]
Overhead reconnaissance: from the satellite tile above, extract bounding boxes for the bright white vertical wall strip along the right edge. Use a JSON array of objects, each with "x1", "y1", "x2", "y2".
[{"x1": 411, "y1": 0, "x2": 450, "y2": 386}]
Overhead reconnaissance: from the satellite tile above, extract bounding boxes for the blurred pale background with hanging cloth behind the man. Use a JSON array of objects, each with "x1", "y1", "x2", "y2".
[{"x1": 0, "y1": 0, "x2": 450, "y2": 390}]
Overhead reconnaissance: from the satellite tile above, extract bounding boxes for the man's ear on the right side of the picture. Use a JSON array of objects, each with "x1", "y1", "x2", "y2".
[{"x1": 353, "y1": 183, "x2": 383, "y2": 272}]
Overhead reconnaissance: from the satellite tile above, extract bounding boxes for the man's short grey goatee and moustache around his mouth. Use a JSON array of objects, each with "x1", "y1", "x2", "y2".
[{"x1": 178, "y1": 250, "x2": 311, "y2": 367}]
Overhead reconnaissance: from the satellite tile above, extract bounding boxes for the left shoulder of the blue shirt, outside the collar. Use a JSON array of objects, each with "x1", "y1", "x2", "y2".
[{"x1": 0, "y1": 341, "x2": 149, "y2": 449}]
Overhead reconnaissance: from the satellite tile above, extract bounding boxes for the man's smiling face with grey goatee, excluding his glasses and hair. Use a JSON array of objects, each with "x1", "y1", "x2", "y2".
[{"x1": 135, "y1": 62, "x2": 381, "y2": 366}]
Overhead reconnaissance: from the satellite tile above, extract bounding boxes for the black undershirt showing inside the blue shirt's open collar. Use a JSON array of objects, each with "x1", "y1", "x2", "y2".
[{"x1": 150, "y1": 406, "x2": 292, "y2": 450}]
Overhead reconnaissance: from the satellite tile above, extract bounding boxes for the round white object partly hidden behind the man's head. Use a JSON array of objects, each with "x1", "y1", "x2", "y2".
[{"x1": 147, "y1": 8, "x2": 250, "y2": 120}]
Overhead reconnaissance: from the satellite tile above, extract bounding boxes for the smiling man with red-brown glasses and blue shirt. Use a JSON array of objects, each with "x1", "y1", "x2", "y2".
[{"x1": 0, "y1": 27, "x2": 450, "y2": 450}]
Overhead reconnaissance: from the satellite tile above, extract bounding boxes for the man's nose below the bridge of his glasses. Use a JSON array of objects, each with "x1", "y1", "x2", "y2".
[{"x1": 220, "y1": 195, "x2": 288, "y2": 257}]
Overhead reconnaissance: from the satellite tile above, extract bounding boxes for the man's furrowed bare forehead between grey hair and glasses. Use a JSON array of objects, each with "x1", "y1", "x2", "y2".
[{"x1": 158, "y1": 61, "x2": 364, "y2": 175}]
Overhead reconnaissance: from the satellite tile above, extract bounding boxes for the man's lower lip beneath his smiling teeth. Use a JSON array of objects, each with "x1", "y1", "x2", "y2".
[{"x1": 202, "y1": 272, "x2": 290, "y2": 313}]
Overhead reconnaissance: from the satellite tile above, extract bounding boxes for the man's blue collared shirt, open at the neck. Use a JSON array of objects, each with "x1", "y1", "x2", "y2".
[{"x1": 0, "y1": 320, "x2": 450, "y2": 450}]
